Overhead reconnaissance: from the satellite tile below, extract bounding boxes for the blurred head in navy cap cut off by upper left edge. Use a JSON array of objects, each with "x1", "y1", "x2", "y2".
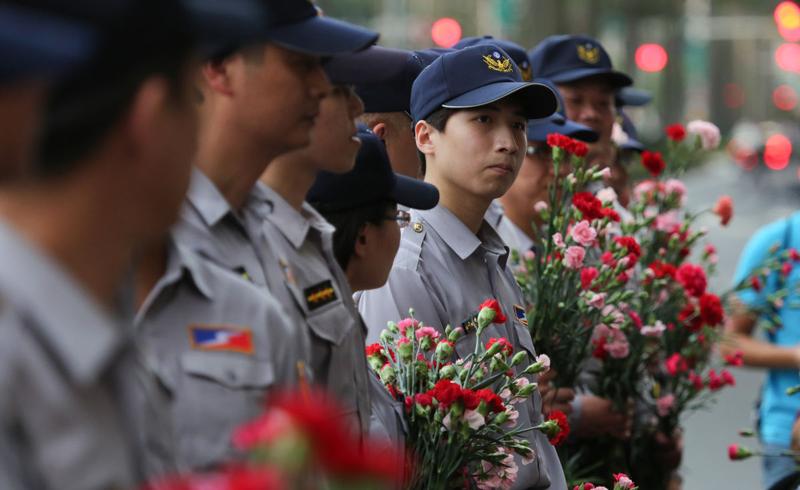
[{"x1": 0, "y1": 2, "x2": 94, "y2": 180}]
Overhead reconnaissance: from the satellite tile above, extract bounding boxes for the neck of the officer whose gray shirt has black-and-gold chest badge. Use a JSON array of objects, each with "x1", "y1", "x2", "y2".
[{"x1": 261, "y1": 151, "x2": 318, "y2": 211}]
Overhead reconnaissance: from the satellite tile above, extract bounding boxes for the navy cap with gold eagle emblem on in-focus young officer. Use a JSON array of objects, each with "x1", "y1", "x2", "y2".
[{"x1": 411, "y1": 43, "x2": 558, "y2": 122}]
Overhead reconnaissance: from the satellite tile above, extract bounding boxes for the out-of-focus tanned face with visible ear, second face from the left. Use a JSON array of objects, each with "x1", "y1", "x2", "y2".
[{"x1": 212, "y1": 44, "x2": 331, "y2": 158}]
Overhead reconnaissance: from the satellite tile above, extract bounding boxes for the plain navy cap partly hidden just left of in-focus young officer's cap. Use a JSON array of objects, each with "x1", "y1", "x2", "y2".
[{"x1": 346, "y1": 46, "x2": 453, "y2": 114}]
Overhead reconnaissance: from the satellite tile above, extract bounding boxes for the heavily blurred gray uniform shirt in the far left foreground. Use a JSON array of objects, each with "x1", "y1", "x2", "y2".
[{"x1": 0, "y1": 222, "x2": 139, "y2": 490}]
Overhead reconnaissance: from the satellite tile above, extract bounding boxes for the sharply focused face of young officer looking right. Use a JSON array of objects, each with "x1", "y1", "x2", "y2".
[{"x1": 416, "y1": 100, "x2": 527, "y2": 200}]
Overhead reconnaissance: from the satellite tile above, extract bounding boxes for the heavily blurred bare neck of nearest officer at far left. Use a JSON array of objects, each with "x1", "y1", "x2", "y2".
[{"x1": 0, "y1": 174, "x2": 135, "y2": 309}]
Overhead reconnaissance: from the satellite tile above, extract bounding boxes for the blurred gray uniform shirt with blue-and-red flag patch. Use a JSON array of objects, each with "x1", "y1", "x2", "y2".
[{"x1": 135, "y1": 237, "x2": 302, "y2": 474}]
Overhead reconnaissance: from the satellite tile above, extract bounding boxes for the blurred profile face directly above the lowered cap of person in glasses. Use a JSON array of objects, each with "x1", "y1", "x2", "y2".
[{"x1": 304, "y1": 86, "x2": 364, "y2": 173}]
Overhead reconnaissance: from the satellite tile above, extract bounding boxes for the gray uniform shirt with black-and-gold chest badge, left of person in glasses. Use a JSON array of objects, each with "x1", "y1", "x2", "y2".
[{"x1": 252, "y1": 183, "x2": 371, "y2": 433}]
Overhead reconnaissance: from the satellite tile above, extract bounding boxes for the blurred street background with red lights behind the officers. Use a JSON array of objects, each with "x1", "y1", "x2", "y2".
[{"x1": 318, "y1": 0, "x2": 800, "y2": 490}]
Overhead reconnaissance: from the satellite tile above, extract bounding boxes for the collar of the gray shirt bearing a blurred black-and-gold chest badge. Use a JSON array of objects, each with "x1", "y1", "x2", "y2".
[{"x1": 254, "y1": 182, "x2": 334, "y2": 248}]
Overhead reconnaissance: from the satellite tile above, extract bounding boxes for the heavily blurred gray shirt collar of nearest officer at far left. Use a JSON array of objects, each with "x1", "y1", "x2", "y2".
[{"x1": 0, "y1": 221, "x2": 129, "y2": 384}]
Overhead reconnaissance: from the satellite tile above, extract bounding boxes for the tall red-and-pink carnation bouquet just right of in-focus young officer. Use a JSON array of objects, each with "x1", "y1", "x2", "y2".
[{"x1": 515, "y1": 134, "x2": 639, "y2": 398}]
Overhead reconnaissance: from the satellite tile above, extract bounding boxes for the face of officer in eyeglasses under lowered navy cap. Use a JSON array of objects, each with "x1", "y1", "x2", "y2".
[{"x1": 347, "y1": 205, "x2": 400, "y2": 290}]
